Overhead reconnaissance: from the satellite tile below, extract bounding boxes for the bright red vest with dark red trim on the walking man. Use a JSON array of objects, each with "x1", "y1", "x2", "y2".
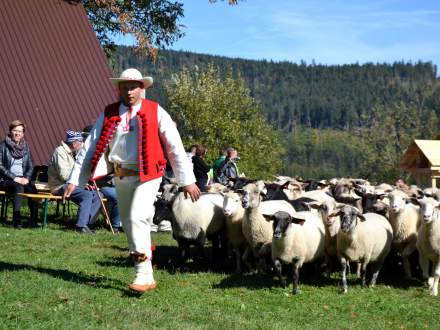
[{"x1": 91, "y1": 99, "x2": 166, "y2": 182}]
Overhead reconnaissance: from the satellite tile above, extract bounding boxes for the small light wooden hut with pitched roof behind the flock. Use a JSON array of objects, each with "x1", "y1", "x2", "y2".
[{"x1": 400, "y1": 140, "x2": 440, "y2": 187}]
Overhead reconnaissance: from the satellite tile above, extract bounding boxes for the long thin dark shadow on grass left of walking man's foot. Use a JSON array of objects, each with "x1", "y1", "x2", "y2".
[{"x1": 0, "y1": 261, "x2": 124, "y2": 290}]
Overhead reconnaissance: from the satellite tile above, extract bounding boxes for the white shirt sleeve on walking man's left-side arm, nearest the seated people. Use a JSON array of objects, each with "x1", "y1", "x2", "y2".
[{"x1": 67, "y1": 112, "x2": 104, "y2": 186}]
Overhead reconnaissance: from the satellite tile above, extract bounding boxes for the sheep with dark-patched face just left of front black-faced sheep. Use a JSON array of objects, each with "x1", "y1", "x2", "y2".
[{"x1": 242, "y1": 181, "x2": 295, "y2": 269}]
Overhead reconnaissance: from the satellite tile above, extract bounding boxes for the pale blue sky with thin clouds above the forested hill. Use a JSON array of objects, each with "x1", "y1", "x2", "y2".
[{"x1": 152, "y1": 0, "x2": 440, "y2": 67}]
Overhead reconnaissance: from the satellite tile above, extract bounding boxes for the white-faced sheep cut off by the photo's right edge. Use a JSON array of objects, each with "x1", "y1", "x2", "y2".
[{"x1": 417, "y1": 197, "x2": 440, "y2": 296}]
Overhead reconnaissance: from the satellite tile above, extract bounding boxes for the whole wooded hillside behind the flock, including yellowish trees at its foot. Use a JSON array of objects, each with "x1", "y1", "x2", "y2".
[{"x1": 113, "y1": 47, "x2": 440, "y2": 182}]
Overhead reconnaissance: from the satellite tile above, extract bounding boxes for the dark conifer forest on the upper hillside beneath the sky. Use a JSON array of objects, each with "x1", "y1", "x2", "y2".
[{"x1": 113, "y1": 47, "x2": 440, "y2": 131}]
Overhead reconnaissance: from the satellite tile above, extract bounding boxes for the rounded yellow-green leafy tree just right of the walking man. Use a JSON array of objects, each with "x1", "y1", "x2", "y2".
[{"x1": 166, "y1": 65, "x2": 284, "y2": 178}]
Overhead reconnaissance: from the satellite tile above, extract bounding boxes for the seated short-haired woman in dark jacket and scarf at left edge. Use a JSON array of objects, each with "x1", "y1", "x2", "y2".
[{"x1": 0, "y1": 120, "x2": 37, "y2": 228}]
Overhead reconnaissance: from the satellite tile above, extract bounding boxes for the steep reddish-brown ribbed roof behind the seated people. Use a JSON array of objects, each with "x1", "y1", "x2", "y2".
[{"x1": 0, "y1": 0, "x2": 117, "y2": 165}]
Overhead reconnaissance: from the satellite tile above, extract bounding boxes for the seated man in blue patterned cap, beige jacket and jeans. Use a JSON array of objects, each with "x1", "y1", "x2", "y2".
[{"x1": 47, "y1": 131, "x2": 101, "y2": 234}]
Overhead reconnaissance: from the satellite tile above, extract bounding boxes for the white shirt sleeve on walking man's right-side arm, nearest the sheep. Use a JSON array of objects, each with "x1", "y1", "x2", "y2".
[{"x1": 157, "y1": 105, "x2": 196, "y2": 186}]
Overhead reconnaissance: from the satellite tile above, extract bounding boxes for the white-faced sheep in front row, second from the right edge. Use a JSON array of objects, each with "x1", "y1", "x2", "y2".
[{"x1": 388, "y1": 190, "x2": 420, "y2": 279}]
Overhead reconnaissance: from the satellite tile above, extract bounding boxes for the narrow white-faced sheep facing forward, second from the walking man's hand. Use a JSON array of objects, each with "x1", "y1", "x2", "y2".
[{"x1": 223, "y1": 191, "x2": 247, "y2": 274}]
